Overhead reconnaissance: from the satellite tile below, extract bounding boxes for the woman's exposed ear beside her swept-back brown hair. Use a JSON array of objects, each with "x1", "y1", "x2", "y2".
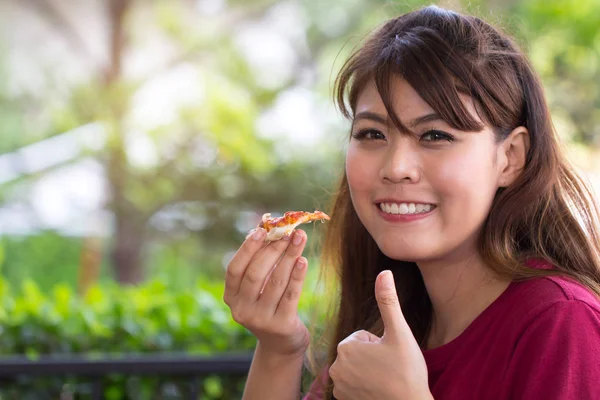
[{"x1": 498, "y1": 126, "x2": 529, "y2": 187}]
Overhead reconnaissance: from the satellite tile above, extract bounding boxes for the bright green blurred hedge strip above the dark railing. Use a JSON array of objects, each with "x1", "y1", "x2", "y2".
[{"x1": 0, "y1": 280, "x2": 254, "y2": 356}]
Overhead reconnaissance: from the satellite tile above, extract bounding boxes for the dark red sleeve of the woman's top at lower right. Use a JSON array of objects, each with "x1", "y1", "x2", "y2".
[{"x1": 501, "y1": 300, "x2": 600, "y2": 400}]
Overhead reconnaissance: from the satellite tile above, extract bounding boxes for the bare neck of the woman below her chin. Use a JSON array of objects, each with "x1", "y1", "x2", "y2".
[{"x1": 418, "y1": 252, "x2": 510, "y2": 349}]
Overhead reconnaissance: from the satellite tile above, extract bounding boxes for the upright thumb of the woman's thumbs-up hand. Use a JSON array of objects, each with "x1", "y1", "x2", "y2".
[{"x1": 375, "y1": 270, "x2": 412, "y2": 342}]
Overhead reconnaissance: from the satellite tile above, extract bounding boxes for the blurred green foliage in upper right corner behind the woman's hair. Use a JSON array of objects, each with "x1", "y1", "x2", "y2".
[{"x1": 512, "y1": 0, "x2": 600, "y2": 151}]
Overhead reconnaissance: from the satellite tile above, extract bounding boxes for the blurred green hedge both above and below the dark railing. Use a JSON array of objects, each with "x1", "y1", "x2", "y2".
[{"x1": 0, "y1": 279, "x2": 324, "y2": 400}]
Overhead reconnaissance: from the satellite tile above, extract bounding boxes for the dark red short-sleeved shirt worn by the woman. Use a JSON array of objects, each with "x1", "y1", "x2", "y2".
[{"x1": 304, "y1": 266, "x2": 600, "y2": 400}]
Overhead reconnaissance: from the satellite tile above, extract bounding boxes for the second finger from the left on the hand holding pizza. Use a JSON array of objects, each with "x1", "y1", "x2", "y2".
[{"x1": 236, "y1": 233, "x2": 290, "y2": 303}]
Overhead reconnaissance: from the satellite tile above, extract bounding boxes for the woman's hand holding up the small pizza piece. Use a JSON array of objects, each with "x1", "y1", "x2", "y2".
[{"x1": 223, "y1": 228, "x2": 309, "y2": 356}]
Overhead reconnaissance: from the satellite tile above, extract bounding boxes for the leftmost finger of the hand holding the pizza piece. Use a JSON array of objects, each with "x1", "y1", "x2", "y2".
[{"x1": 224, "y1": 228, "x2": 267, "y2": 299}]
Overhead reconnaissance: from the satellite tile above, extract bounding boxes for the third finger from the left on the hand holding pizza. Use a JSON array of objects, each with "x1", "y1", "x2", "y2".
[{"x1": 258, "y1": 230, "x2": 306, "y2": 315}]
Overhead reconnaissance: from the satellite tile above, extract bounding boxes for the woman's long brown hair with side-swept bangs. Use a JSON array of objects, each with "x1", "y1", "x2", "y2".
[{"x1": 309, "y1": 6, "x2": 600, "y2": 399}]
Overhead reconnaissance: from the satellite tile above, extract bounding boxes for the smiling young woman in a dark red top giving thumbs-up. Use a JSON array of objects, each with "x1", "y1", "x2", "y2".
[{"x1": 225, "y1": 6, "x2": 600, "y2": 400}]
